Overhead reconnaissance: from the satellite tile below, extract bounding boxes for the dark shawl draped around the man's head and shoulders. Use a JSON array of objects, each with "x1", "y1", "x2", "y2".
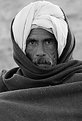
[{"x1": 0, "y1": 9, "x2": 82, "y2": 121}]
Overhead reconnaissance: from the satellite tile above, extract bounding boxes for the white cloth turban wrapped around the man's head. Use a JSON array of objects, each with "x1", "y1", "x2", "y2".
[{"x1": 12, "y1": 1, "x2": 68, "y2": 56}]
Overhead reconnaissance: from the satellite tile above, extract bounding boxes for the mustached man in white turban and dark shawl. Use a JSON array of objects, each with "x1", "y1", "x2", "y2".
[{"x1": 0, "y1": 1, "x2": 82, "y2": 121}]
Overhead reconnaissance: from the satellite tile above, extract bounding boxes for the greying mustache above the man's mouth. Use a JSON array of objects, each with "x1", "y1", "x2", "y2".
[{"x1": 33, "y1": 57, "x2": 52, "y2": 65}]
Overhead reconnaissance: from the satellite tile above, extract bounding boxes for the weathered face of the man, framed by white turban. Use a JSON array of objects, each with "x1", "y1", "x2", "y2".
[{"x1": 26, "y1": 28, "x2": 57, "y2": 68}]
